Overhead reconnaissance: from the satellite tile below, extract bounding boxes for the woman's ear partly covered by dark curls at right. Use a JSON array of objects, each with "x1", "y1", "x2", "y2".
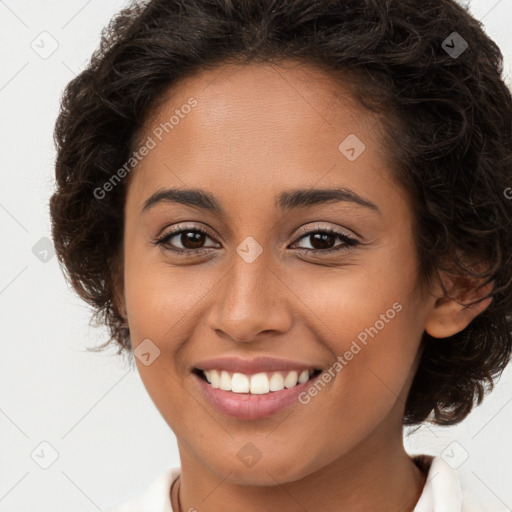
[{"x1": 425, "y1": 268, "x2": 494, "y2": 338}]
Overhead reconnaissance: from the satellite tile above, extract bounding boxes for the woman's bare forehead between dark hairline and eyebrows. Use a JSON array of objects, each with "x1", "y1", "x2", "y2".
[{"x1": 129, "y1": 61, "x2": 400, "y2": 220}]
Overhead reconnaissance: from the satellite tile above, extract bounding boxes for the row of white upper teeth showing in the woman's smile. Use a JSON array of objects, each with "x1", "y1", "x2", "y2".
[{"x1": 203, "y1": 370, "x2": 314, "y2": 395}]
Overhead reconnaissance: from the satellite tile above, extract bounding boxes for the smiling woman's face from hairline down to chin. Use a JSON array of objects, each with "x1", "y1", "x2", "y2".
[{"x1": 123, "y1": 60, "x2": 432, "y2": 485}]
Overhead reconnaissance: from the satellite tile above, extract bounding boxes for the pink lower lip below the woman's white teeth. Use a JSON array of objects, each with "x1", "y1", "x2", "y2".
[{"x1": 192, "y1": 373, "x2": 321, "y2": 420}]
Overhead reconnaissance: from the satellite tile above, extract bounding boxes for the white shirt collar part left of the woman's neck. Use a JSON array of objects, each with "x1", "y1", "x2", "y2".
[{"x1": 105, "y1": 467, "x2": 181, "y2": 512}]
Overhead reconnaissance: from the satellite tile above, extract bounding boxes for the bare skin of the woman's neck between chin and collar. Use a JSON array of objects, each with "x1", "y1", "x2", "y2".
[{"x1": 171, "y1": 416, "x2": 426, "y2": 512}]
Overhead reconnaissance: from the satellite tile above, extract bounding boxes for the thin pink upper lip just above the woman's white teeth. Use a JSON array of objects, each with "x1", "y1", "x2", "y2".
[{"x1": 194, "y1": 356, "x2": 321, "y2": 375}]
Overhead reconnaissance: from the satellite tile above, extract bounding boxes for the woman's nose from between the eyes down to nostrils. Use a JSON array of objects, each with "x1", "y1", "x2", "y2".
[{"x1": 208, "y1": 246, "x2": 290, "y2": 341}]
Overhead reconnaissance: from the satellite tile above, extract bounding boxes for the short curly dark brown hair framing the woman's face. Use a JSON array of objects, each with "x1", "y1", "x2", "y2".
[{"x1": 50, "y1": 0, "x2": 512, "y2": 425}]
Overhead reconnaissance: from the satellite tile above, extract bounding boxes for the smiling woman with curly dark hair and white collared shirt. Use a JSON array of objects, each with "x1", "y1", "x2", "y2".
[{"x1": 51, "y1": 0, "x2": 512, "y2": 512}]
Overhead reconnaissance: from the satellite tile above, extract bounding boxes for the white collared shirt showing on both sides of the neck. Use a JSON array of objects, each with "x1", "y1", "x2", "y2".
[{"x1": 106, "y1": 455, "x2": 489, "y2": 512}]
